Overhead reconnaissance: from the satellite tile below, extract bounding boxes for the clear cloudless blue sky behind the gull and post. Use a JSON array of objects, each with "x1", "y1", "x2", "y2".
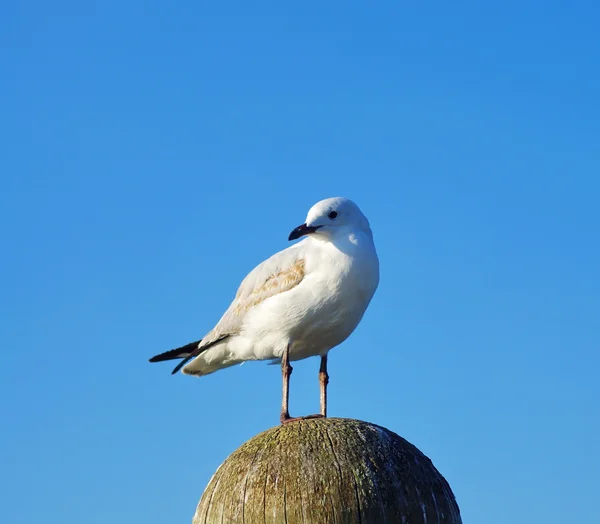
[{"x1": 0, "y1": 0, "x2": 600, "y2": 524}]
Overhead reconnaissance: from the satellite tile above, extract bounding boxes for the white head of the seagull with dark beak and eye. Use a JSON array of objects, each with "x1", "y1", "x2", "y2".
[{"x1": 289, "y1": 197, "x2": 371, "y2": 240}]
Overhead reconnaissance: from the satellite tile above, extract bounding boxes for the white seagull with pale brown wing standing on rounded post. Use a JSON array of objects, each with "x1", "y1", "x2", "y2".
[{"x1": 150, "y1": 197, "x2": 379, "y2": 424}]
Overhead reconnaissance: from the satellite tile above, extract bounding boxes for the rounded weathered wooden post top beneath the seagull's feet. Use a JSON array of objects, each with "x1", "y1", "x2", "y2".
[{"x1": 193, "y1": 418, "x2": 462, "y2": 524}]
